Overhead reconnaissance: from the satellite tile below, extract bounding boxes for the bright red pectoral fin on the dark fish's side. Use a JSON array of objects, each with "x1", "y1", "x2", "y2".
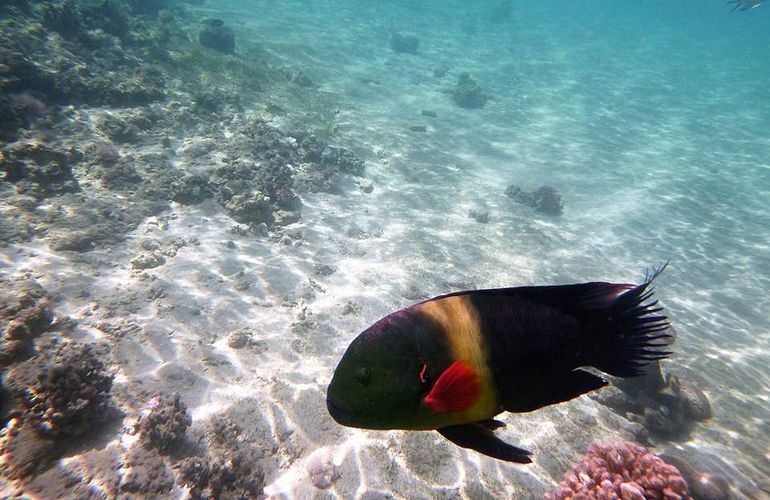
[{"x1": 423, "y1": 361, "x2": 481, "y2": 412}]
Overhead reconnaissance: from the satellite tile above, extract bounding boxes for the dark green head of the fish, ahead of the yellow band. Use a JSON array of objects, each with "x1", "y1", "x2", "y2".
[{"x1": 326, "y1": 311, "x2": 436, "y2": 429}]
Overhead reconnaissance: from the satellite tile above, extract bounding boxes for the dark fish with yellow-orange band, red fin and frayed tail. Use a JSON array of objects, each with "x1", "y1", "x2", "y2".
[{"x1": 326, "y1": 264, "x2": 674, "y2": 464}]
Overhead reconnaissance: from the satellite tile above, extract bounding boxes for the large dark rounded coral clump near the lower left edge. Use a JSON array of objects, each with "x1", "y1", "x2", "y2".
[{"x1": 6, "y1": 343, "x2": 112, "y2": 437}]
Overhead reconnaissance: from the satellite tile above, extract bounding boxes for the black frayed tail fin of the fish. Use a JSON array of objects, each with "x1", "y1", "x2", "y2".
[{"x1": 586, "y1": 262, "x2": 674, "y2": 377}]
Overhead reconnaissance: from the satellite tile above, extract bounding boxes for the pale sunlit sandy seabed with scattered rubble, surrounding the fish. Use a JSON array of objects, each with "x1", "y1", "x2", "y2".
[{"x1": 0, "y1": 2, "x2": 770, "y2": 499}]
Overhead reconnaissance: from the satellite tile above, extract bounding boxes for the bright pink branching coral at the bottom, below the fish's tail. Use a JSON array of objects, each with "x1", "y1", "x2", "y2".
[{"x1": 545, "y1": 441, "x2": 692, "y2": 500}]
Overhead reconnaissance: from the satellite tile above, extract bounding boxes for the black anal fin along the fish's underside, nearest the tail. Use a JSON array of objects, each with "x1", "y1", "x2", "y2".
[{"x1": 502, "y1": 369, "x2": 607, "y2": 413}]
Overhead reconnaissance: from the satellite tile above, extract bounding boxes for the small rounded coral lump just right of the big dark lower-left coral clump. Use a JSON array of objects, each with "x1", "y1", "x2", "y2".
[{"x1": 136, "y1": 394, "x2": 192, "y2": 453}]
